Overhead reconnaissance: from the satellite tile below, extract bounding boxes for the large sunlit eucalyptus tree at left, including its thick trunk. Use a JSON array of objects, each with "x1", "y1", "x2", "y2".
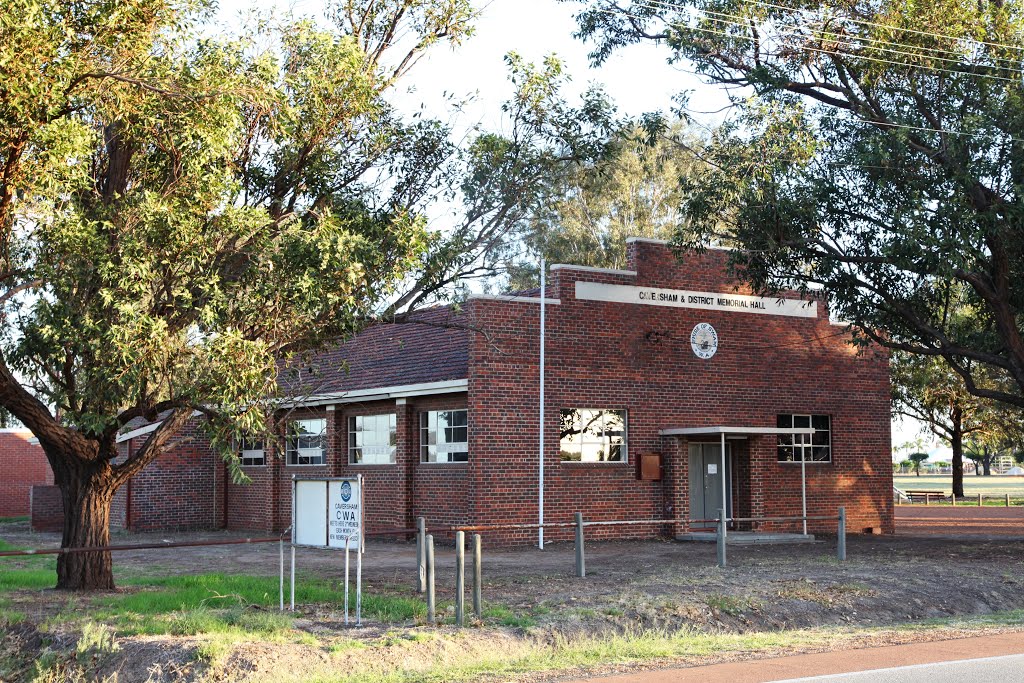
[{"x1": 0, "y1": 0, "x2": 611, "y2": 589}]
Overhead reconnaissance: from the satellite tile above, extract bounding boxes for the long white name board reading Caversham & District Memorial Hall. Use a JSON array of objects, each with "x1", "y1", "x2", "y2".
[{"x1": 575, "y1": 282, "x2": 818, "y2": 317}]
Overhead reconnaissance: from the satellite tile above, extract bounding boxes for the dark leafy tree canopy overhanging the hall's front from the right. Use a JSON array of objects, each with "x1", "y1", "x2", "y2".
[{"x1": 579, "y1": 0, "x2": 1024, "y2": 408}]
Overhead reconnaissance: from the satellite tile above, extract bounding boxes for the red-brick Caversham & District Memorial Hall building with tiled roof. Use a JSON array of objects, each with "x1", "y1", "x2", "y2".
[{"x1": 75, "y1": 240, "x2": 893, "y2": 542}]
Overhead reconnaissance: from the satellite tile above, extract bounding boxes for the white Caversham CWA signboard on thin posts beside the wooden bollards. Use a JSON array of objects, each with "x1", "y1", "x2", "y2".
[{"x1": 292, "y1": 476, "x2": 362, "y2": 550}]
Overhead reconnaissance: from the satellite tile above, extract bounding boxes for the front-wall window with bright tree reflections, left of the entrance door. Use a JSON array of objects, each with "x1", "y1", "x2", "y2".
[{"x1": 558, "y1": 408, "x2": 627, "y2": 463}]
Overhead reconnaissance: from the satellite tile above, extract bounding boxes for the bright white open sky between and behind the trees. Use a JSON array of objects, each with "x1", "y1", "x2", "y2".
[{"x1": 216, "y1": 0, "x2": 929, "y2": 460}]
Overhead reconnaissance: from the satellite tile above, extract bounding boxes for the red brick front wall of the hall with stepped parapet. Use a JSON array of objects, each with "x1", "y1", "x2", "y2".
[{"x1": 467, "y1": 242, "x2": 893, "y2": 539}]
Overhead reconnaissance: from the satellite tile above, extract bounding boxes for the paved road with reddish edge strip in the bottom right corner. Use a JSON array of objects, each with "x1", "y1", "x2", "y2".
[{"x1": 573, "y1": 633, "x2": 1024, "y2": 683}]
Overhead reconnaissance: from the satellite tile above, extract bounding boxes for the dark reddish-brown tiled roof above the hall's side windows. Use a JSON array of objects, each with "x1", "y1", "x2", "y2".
[{"x1": 279, "y1": 307, "x2": 470, "y2": 397}]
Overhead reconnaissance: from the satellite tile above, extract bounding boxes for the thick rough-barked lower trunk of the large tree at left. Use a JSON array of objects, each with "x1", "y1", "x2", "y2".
[{"x1": 54, "y1": 461, "x2": 116, "y2": 591}]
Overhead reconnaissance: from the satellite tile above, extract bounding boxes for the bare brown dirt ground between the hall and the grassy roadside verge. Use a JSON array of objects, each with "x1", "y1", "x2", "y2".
[{"x1": 6, "y1": 523, "x2": 1024, "y2": 680}]
